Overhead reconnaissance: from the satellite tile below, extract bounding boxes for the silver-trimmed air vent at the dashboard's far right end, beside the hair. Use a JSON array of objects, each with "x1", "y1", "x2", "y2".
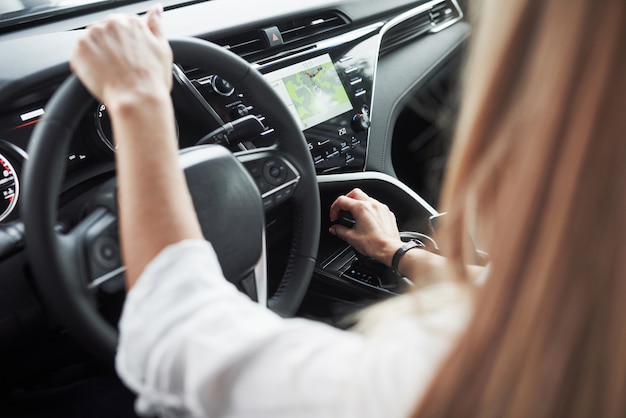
[{"x1": 380, "y1": 0, "x2": 462, "y2": 55}]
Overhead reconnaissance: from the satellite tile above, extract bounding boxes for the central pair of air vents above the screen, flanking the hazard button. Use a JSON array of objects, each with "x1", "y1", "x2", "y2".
[{"x1": 212, "y1": 12, "x2": 349, "y2": 61}]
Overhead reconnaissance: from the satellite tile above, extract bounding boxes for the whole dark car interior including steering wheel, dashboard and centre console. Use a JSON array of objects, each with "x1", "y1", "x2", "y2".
[{"x1": 0, "y1": 0, "x2": 470, "y2": 416}]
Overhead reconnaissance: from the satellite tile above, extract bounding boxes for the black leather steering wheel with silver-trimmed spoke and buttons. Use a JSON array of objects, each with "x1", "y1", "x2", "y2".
[{"x1": 22, "y1": 39, "x2": 320, "y2": 364}]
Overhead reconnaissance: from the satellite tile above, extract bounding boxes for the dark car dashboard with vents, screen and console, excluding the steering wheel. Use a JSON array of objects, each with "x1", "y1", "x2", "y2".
[{"x1": 0, "y1": 0, "x2": 469, "y2": 396}]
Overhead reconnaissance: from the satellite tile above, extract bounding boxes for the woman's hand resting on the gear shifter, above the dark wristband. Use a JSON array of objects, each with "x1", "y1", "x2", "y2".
[{"x1": 329, "y1": 189, "x2": 402, "y2": 266}]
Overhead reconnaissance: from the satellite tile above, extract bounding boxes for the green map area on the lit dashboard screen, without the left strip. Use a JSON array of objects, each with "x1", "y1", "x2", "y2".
[{"x1": 283, "y1": 62, "x2": 352, "y2": 128}]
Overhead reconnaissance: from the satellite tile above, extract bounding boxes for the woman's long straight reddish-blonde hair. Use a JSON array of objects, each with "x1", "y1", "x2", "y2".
[{"x1": 414, "y1": 0, "x2": 626, "y2": 418}]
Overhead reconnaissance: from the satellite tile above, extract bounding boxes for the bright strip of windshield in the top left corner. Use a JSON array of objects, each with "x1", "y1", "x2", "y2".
[{"x1": 0, "y1": 0, "x2": 117, "y2": 27}]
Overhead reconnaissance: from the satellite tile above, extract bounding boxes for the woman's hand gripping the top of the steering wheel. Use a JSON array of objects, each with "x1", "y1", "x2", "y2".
[{"x1": 70, "y1": 6, "x2": 172, "y2": 111}]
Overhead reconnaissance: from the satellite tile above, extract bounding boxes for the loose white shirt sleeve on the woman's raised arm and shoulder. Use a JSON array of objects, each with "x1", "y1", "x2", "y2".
[{"x1": 116, "y1": 241, "x2": 460, "y2": 418}]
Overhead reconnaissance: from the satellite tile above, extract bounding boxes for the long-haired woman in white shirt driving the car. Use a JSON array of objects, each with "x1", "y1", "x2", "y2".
[{"x1": 72, "y1": 0, "x2": 626, "y2": 417}]
